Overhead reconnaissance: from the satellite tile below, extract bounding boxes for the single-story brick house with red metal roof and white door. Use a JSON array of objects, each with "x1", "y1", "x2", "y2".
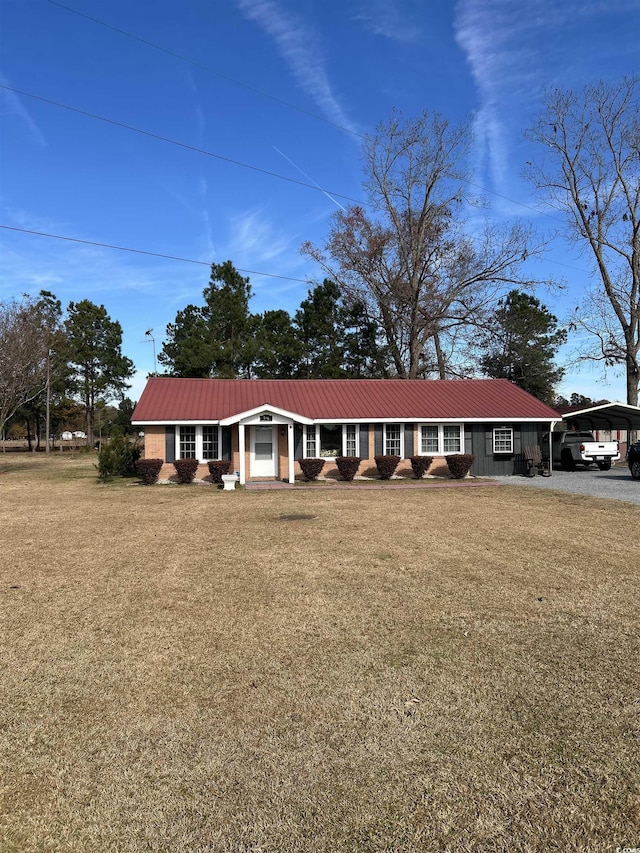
[{"x1": 131, "y1": 376, "x2": 561, "y2": 483}]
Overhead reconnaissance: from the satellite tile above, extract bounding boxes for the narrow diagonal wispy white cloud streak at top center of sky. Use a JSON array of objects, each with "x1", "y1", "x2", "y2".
[{"x1": 237, "y1": 0, "x2": 359, "y2": 133}]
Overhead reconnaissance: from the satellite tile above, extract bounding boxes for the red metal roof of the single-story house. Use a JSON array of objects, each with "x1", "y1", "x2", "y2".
[{"x1": 132, "y1": 376, "x2": 560, "y2": 425}]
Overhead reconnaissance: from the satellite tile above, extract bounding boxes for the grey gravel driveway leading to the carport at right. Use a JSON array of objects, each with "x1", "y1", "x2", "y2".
[{"x1": 494, "y1": 461, "x2": 640, "y2": 504}]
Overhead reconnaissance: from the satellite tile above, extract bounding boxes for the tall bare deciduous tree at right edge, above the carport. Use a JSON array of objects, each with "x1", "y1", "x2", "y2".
[{"x1": 527, "y1": 77, "x2": 640, "y2": 406}]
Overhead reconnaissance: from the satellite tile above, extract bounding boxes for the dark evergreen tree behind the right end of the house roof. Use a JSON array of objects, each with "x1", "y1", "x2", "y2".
[{"x1": 480, "y1": 290, "x2": 567, "y2": 404}]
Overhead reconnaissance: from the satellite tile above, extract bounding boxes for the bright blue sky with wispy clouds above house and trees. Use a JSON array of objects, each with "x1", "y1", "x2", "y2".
[{"x1": 0, "y1": 0, "x2": 640, "y2": 400}]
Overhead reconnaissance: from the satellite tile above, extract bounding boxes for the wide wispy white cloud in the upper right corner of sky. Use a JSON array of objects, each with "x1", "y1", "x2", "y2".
[{"x1": 454, "y1": 0, "x2": 638, "y2": 206}]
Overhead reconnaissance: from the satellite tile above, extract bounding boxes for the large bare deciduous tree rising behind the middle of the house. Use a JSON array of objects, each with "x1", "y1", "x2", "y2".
[{"x1": 302, "y1": 112, "x2": 538, "y2": 379}]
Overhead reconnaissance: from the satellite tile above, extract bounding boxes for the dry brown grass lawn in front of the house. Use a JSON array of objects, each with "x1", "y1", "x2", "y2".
[{"x1": 0, "y1": 456, "x2": 640, "y2": 853}]
